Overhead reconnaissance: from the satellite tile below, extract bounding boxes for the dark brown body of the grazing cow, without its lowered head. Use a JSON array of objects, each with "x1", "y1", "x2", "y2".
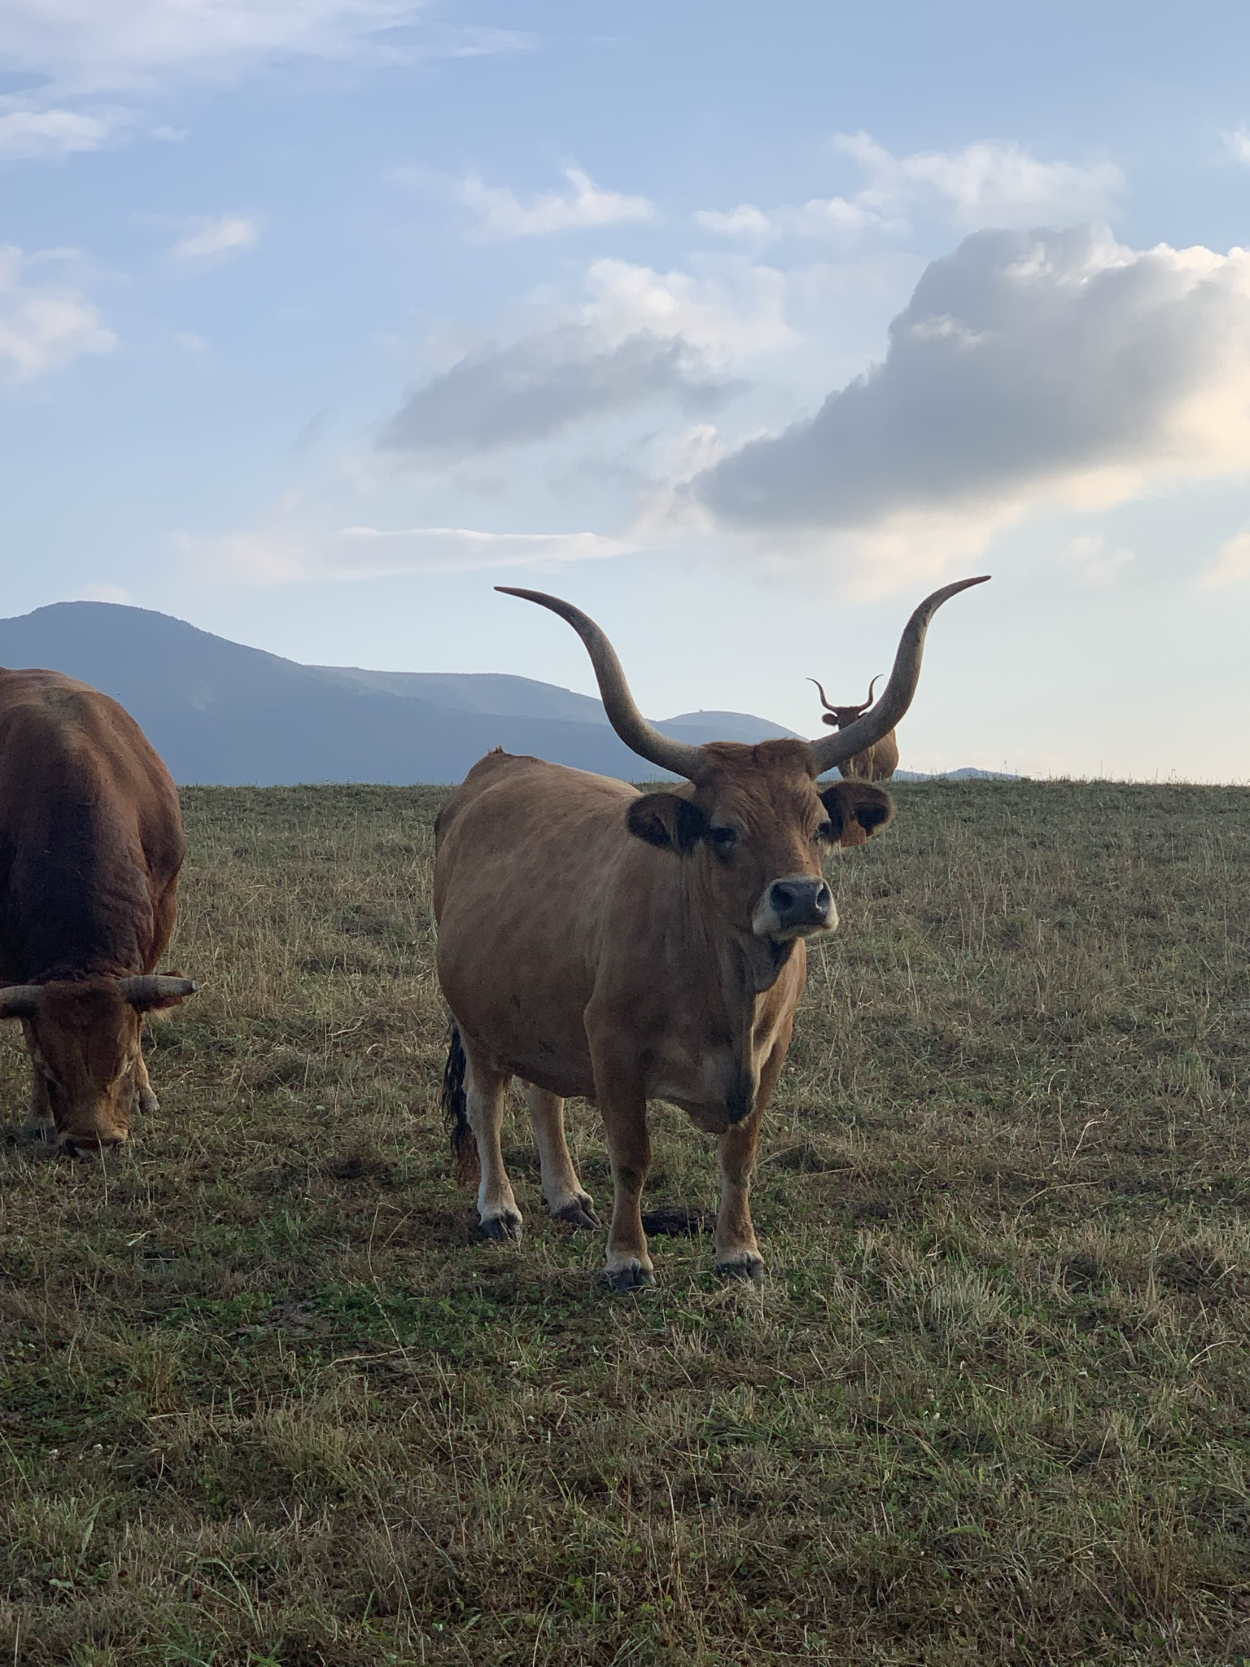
[{"x1": 0, "y1": 670, "x2": 185, "y2": 982}]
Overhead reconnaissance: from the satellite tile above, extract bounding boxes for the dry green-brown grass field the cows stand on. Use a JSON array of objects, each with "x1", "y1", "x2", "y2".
[{"x1": 0, "y1": 783, "x2": 1250, "y2": 1667}]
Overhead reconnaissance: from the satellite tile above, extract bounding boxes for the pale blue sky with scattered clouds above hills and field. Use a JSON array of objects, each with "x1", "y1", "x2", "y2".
[{"x1": 0, "y1": 0, "x2": 1250, "y2": 783}]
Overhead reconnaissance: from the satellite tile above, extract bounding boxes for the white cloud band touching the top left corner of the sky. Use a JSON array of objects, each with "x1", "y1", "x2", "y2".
[{"x1": 0, "y1": 0, "x2": 528, "y2": 92}]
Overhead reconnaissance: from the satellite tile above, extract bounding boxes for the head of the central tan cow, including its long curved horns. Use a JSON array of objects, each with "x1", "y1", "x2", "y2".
[{"x1": 498, "y1": 578, "x2": 983, "y2": 944}]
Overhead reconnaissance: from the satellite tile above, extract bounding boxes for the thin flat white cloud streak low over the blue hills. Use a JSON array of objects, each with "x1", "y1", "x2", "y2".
[{"x1": 177, "y1": 530, "x2": 632, "y2": 588}]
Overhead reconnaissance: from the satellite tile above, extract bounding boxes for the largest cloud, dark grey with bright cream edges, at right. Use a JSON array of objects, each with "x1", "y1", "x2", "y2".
[{"x1": 693, "y1": 230, "x2": 1250, "y2": 588}]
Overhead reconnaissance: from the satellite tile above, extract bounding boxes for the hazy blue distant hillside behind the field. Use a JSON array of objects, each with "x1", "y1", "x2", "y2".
[{"x1": 0, "y1": 602, "x2": 803, "y2": 785}]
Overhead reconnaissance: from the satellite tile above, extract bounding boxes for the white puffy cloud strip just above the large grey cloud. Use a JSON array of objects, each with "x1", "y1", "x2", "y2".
[{"x1": 695, "y1": 133, "x2": 1125, "y2": 245}]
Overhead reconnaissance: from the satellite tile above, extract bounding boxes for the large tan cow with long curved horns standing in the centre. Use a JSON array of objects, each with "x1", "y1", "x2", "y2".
[{"x1": 433, "y1": 578, "x2": 982, "y2": 1290}]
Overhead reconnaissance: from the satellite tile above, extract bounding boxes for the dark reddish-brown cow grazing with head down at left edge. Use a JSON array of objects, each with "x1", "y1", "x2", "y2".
[{"x1": 0, "y1": 670, "x2": 195, "y2": 1155}]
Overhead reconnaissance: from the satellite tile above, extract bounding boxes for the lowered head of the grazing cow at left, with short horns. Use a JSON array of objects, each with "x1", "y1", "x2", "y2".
[{"x1": 0, "y1": 974, "x2": 195, "y2": 1157}]
